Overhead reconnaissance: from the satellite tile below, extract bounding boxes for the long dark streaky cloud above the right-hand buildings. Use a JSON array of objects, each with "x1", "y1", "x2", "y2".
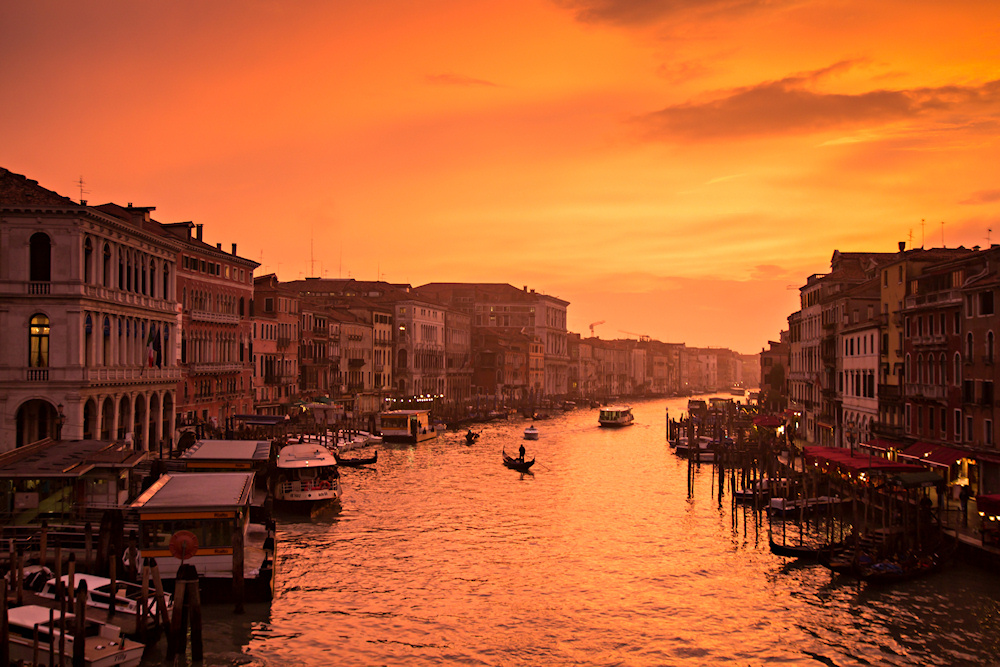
[{"x1": 636, "y1": 66, "x2": 1000, "y2": 141}]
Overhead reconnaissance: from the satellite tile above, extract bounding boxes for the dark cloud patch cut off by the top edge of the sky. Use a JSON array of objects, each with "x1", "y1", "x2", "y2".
[{"x1": 555, "y1": 0, "x2": 788, "y2": 26}]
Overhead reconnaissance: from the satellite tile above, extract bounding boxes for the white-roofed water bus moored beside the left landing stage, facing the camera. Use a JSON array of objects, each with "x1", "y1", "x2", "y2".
[{"x1": 274, "y1": 442, "x2": 341, "y2": 512}]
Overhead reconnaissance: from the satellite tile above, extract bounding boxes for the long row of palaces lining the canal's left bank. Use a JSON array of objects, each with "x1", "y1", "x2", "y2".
[{"x1": 0, "y1": 169, "x2": 759, "y2": 451}]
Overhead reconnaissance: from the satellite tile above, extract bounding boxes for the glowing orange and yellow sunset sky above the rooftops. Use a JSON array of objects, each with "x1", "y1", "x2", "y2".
[{"x1": 0, "y1": 0, "x2": 1000, "y2": 353}]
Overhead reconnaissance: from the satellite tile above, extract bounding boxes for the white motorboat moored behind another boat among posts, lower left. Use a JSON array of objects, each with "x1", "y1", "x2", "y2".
[{"x1": 18, "y1": 565, "x2": 171, "y2": 636}]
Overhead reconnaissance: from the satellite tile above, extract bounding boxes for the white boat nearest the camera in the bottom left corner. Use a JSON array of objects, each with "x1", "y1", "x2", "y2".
[{"x1": 7, "y1": 604, "x2": 146, "y2": 667}]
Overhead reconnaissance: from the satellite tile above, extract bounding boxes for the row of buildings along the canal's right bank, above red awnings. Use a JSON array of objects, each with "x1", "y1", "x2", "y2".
[{"x1": 761, "y1": 243, "x2": 1000, "y2": 493}]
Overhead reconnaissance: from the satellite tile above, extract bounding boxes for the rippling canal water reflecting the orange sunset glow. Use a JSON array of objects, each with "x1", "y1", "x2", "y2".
[{"x1": 144, "y1": 399, "x2": 1000, "y2": 667}]
